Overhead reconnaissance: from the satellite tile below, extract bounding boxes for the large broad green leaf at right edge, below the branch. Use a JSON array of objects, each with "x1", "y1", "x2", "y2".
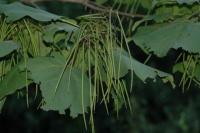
[{"x1": 133, "y1": 21, "x2": 200, "y2": 57}]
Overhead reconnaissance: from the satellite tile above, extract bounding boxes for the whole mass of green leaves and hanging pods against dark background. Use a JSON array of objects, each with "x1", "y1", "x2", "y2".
[{"x1": 0, "y1": 0, "x2": 200, "y2": 132}]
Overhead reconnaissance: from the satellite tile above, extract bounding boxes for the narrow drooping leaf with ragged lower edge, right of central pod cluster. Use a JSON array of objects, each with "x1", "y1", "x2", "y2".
[{"x1": 114, "y1": 49, "x2": 174, "y2": 86}]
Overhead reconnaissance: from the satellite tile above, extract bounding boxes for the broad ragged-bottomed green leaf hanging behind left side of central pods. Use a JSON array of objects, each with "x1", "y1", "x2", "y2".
[{"x1": 28, "y1": 56, "x2": 90, "y2": 117}]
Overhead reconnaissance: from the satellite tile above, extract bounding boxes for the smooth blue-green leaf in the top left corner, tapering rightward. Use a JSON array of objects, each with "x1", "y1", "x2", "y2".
[{"x1": 0, "y1": 2, "x2": 61, "y2": 22}]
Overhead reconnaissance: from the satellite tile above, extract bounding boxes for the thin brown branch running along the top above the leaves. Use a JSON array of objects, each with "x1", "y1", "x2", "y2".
[{"x1": 21, "y1": 0, "x2": 144, "y2": 18}]
